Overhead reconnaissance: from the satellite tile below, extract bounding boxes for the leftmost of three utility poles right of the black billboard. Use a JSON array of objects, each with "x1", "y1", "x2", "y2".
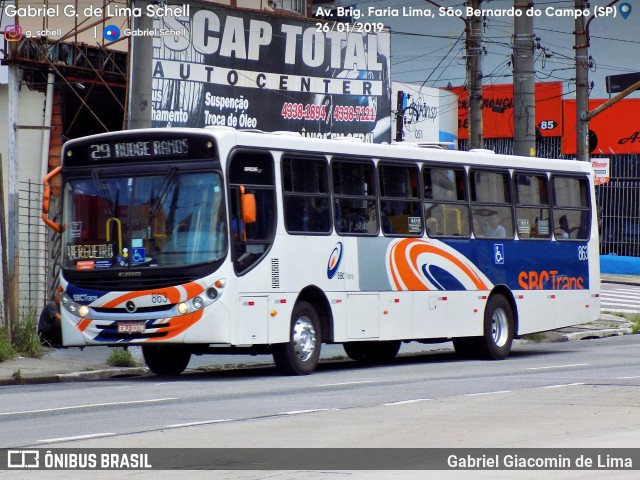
[{"x1": 466, "y1": 0, "x2": 484, "y2": 148}]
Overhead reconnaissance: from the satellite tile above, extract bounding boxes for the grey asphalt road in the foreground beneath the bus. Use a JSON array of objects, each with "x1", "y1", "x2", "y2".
[{"x1": 0, "y1": 336, "x2": 640, "y2": 454}]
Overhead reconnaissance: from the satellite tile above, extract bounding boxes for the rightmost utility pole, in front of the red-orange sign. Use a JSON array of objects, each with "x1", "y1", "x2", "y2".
[{"x1": 574, "y1": 0, "x2": 589, "y2": 162}]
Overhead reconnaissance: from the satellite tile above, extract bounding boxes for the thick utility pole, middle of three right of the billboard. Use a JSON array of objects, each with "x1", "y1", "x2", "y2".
[{"x1": 513, "y1": 0, "x2": 536, "y2": 157}]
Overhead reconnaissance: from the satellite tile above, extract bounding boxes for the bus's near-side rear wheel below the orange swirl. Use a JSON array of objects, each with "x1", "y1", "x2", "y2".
[{"x1": 453, "y1": 295, "x2": 515, "y2": 360}]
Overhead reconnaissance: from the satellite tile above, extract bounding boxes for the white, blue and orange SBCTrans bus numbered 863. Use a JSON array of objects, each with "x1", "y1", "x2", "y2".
[{"x1": 43, "y1": 128, "x2": 600, "y2": 374}]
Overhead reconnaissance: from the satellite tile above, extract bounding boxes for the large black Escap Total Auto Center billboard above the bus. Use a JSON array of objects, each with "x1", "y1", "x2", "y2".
[{"x1": 138, "y1": 2, "x2": 391, "y2": 143}]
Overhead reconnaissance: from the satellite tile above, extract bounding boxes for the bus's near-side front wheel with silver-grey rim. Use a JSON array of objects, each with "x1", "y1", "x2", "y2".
[{"x1": 273, "y1": 302, "x2": 322, "y2": 375}]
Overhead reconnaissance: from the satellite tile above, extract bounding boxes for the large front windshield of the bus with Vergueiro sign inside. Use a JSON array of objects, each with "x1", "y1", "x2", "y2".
[{"x1": 62, "y1": 167, "x2": 227, "y2": 270}]
